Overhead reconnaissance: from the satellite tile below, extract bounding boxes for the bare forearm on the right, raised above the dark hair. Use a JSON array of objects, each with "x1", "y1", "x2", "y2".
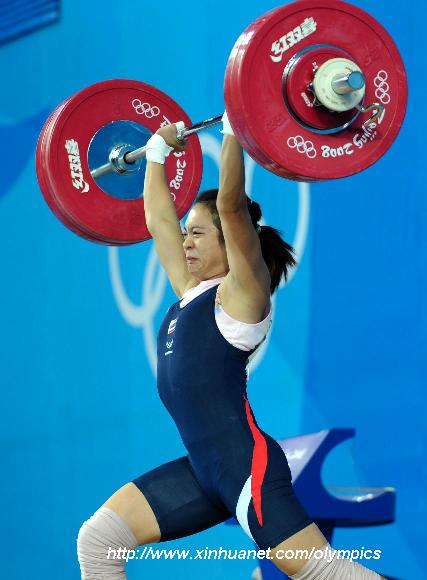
[{"x1": 217, "y1": 135, "x2": 246, "y2": 211}]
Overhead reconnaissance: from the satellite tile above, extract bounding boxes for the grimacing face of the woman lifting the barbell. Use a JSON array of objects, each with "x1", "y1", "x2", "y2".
[{"x1": 183, "y1": 204, "x2": 228, "y2": 280}]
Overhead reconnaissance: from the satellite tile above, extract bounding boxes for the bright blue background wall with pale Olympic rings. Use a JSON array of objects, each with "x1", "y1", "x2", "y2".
[{"x1": 0, "y1": 0, "x2": 427, "y2": 580}]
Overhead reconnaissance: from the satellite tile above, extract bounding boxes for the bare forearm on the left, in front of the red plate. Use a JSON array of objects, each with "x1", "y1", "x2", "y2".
[{"x1": 144, "y1": 161, "x2": 179, "y2": 231}]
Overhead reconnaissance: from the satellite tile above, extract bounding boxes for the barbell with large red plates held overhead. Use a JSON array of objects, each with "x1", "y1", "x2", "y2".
[{"x1": 36, "y1": 0, "x2": 407, "y2": 245}]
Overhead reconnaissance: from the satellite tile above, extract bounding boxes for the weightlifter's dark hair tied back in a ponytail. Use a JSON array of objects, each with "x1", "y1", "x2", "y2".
[{"x1": 195, "y1": 189, "x2": 296, "y2": 294}]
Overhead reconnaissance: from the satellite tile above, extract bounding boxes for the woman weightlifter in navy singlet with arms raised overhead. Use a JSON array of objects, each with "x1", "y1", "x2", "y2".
[{"x1": 77, "y1": 115, "x2": 388, "y2": 580}]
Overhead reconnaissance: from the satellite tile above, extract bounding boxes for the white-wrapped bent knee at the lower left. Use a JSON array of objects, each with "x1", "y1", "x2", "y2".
[{"x1": 77, "y1": 508, "x2": 138, "y2": 580}]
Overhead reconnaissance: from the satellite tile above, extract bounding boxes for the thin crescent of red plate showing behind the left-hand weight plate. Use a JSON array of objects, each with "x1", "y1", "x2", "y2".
[{"x1": 36, "y1": 101, "x2": 111, "y2": 242}]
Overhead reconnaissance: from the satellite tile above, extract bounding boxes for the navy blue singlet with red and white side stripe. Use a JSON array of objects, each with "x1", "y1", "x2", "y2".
[{"x1": 133, "y1": 286, "x2": 312, "y2": 549}]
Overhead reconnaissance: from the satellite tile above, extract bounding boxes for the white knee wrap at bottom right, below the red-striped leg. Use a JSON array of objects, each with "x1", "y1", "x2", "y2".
[{"x1": 291, "y1": 544, "x2": 382, "y2": 580}]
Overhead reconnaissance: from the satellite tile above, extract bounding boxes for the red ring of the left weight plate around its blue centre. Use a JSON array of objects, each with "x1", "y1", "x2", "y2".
[{"x1": 40, "y1": 80, "x2": 202, "y2": 245}]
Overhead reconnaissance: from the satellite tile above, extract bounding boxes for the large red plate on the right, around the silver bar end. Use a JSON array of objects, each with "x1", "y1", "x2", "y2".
[{"x1": 224, "y1": 0, "x2": 407, "y2": 181}]
